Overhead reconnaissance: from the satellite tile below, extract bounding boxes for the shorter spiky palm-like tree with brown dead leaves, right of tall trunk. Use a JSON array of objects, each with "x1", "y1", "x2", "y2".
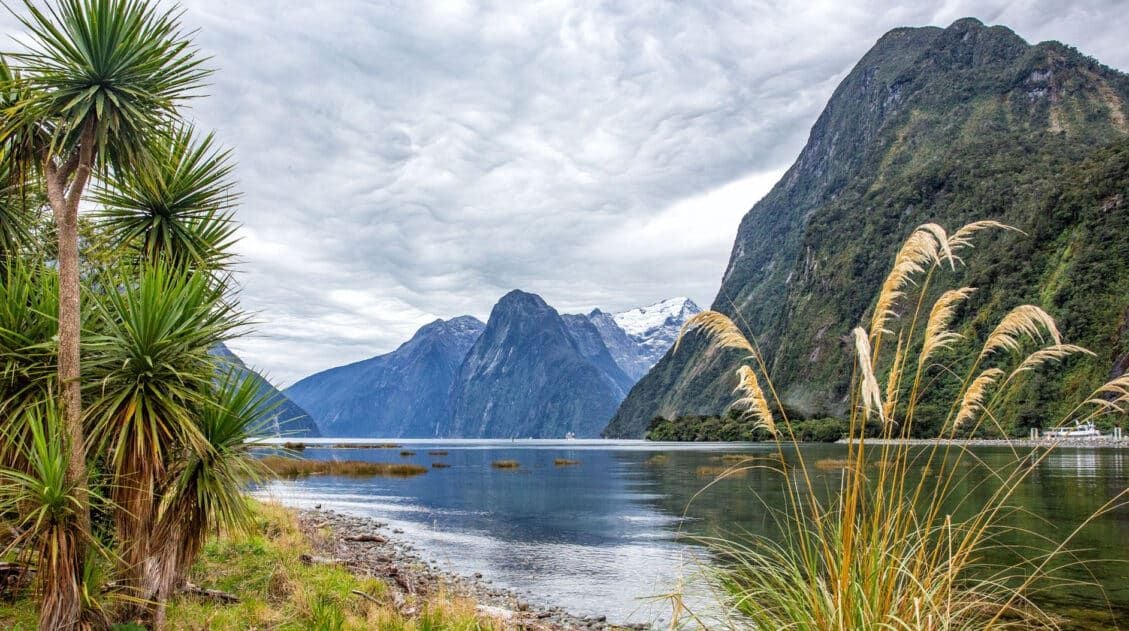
[{"x1": 87, "y1": 261, "x2": 240, "y2": 596}]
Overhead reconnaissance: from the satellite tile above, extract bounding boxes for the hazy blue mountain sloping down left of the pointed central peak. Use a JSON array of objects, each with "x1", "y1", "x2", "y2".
[{"x1": 286, "y1": 316, "x2": 484, "y2": 438}]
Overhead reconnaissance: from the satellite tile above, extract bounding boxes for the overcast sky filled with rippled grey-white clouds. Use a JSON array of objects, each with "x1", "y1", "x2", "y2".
[{"x1": 6, "y1": 0, "x2": 1129, "y2": 385}]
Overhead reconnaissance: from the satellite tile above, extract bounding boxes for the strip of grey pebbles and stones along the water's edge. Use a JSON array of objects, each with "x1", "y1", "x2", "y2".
[{"x1": 298, "y1": 509, "x2": 651, "y2": 631}]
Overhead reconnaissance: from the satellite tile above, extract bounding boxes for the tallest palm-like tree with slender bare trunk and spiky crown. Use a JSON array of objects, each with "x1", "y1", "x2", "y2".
[{"x1": 0, "y1": 0, "x2": 208, "y2": 628}]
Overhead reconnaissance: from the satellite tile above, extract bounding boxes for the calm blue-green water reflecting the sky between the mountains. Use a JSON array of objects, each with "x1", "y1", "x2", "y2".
[{"x1": 251, "y1": 439, "x2": 1129, "y2": 624}]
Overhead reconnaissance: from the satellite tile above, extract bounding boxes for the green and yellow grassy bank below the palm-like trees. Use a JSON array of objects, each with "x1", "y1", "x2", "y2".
[{"x1": 0, "y1": 503, "x2": 504, "y2": 631}]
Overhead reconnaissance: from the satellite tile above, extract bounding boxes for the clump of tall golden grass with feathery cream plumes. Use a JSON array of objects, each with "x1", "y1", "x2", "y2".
[{"x1": 675, "y1": 221, "x2": 1129, "y2": 630}]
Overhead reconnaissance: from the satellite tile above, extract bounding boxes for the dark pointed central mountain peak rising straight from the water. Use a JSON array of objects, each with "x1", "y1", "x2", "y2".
[{"x1": 438, "y1": 290, "x2": 629, "y2": 438}]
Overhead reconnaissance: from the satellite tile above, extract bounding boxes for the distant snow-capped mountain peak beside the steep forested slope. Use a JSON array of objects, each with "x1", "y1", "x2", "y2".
[{"x1": 588, "y1": 298, "x2": 701, "y2": 382}]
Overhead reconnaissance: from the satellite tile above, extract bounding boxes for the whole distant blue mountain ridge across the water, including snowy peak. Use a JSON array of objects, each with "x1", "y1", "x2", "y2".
[{"x1": 286, "y1": 290, "x2": 698, "y2": 438}]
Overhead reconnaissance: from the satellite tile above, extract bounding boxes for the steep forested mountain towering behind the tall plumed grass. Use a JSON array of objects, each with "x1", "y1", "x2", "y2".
[{"x1": 604, "y1": 18, "x2": 1129, "y2": 437}]
